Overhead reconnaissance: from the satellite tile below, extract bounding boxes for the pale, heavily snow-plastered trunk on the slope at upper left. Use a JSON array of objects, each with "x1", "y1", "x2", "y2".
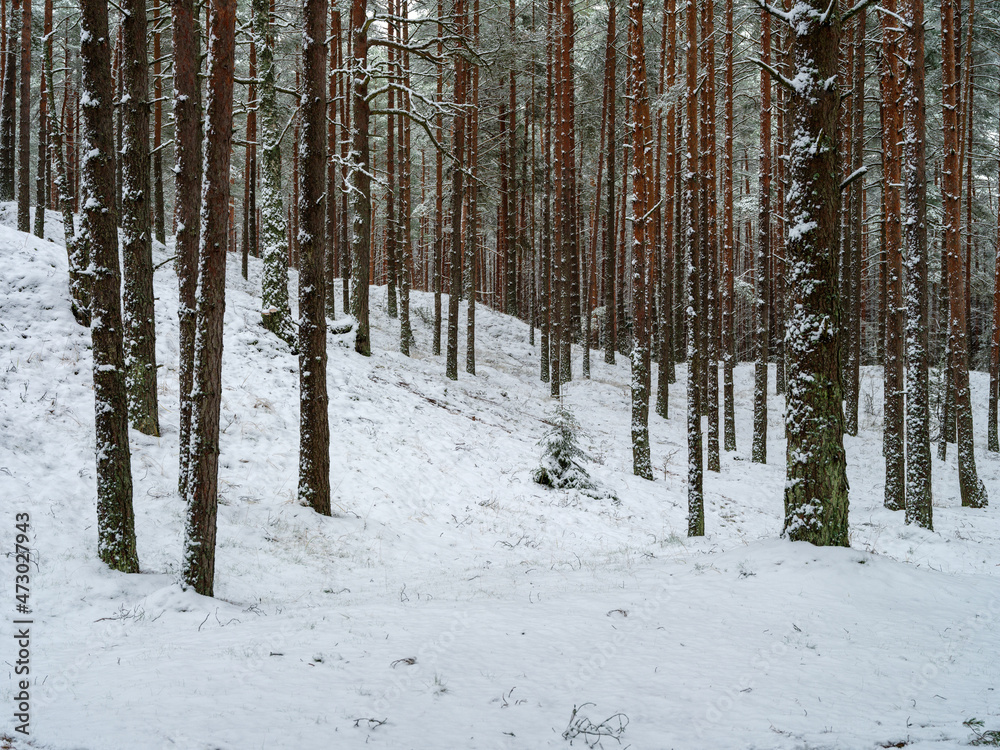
[{"x1": 253, "y1": 0, "x2": 295, "y2": 347}]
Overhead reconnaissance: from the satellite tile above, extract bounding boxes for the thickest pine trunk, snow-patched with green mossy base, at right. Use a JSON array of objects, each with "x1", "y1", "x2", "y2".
[{"x1": 784, "y1": 0, "x2": 848, "y2": 546}]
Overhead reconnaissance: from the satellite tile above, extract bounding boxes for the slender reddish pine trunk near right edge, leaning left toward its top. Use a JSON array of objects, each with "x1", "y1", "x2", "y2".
[{"x1": 941, "y1": 0, "x2": 989, "y2": 508}]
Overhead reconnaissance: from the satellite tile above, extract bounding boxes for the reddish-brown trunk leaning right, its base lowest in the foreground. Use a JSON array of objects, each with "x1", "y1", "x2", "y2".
[{"x1": 181, "y1": 0, "x2": 236, "y2": 596}]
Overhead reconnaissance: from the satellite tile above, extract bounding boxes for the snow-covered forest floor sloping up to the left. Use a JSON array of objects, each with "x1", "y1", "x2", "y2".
[{"x1": 0, "y1": 210, "x2": 1000, "y2": 750}]
